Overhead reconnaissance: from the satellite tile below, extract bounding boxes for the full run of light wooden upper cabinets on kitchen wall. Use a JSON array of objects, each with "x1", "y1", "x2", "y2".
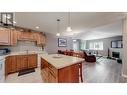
[{"x1": 0, "y1": 28, "x2": 46, "y2": 46}]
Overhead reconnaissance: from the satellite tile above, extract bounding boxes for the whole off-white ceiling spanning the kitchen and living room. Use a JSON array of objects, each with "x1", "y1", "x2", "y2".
[{"x1": 15, "y1": 12, "x2": 125, "y2": 38}]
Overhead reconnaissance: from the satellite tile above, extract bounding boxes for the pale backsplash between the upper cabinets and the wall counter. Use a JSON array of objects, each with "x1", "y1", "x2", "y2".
[{"x1": 0, "y1": 41, "x2": 42, "y2": 52}]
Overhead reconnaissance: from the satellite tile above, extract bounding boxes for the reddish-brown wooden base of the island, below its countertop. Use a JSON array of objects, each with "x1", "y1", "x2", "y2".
[{"x1": 41, "y1": 58, "x2": 82, "y2": 83}]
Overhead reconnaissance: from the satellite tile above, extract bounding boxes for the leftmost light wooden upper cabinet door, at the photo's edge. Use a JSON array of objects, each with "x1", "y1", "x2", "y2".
[{"x1": 0, "y1": 28, "x2": 10, "y2": 45}]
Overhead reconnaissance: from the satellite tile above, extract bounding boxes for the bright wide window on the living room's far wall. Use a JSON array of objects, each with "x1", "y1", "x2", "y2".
[{"x1": 89, "y1": 42, "x2": 103, "y2": 50}]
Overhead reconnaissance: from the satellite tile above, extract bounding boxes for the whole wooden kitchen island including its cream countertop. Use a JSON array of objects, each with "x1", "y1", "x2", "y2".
[{"x1": 41, "y1": 54, "x2": 84, "y2": 83}]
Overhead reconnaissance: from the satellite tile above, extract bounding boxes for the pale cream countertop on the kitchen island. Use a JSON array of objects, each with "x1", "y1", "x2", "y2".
[{"x1": 41, "y1": 54, "x2": 84, "y2": 69}]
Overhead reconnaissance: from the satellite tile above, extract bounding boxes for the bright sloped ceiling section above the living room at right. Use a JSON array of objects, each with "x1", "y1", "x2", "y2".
[{"x1": 76, "y1": 20, "x2": 122, "y2": 40}]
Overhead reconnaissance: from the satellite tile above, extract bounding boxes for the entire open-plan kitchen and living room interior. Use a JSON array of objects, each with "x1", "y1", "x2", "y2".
[{"x1": 0, "y1": 12, "x2": 127, "y2": 83}]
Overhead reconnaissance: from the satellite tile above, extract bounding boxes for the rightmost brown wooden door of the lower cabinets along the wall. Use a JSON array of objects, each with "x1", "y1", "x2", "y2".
[{"x1": 28, "y1": 54, "x2": 37, "y2": 68}]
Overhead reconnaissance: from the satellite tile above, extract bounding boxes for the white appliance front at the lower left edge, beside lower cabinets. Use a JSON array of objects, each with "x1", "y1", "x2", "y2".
[{"x1": 0, "y1": 58, "x2": 5, "y2": 83}]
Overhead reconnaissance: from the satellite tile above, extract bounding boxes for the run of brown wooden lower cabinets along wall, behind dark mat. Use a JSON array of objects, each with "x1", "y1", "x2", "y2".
[{"x1": 5, "y1": 54, "x2": 37, "y2": 75}]
